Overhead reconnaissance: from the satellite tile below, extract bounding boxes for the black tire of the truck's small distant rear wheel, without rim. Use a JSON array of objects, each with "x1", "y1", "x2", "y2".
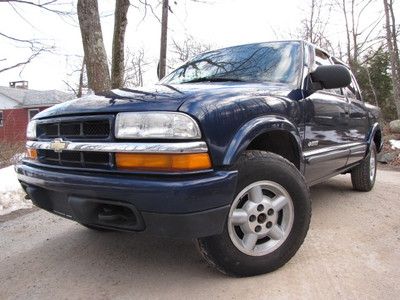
[{"x1": 351, "y1": 142, "x2": 377, "y2": 192}]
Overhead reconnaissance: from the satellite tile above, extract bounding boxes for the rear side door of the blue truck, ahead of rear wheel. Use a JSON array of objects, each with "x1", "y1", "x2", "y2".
[{"x1": 344, "y1": 74, "x2": 369, "y2": 165}]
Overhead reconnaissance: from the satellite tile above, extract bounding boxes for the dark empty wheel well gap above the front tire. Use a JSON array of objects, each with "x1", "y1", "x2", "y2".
[{"x1": 246, "y1": 130, "x2": 300, "y2": 169}]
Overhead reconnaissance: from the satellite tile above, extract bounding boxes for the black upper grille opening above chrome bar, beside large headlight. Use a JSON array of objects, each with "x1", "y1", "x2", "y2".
[{"x1": 37, "y1": 119, "x2": 111, "y2": 139}]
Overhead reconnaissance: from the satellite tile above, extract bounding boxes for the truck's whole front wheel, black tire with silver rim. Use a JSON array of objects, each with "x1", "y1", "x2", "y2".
[{"x1": 198, "y1": 151, "x2": 311, "y2": 276}]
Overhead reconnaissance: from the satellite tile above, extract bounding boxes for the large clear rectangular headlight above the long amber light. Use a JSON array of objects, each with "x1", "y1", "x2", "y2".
[{"x1": 115, "y1": 112, "x2": 201, "y2": 139}]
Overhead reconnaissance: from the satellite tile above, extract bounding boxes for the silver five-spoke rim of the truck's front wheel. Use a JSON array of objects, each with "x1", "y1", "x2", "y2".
[{"x1": 228, "y1": 181, "x2": 294, "y2": 256}]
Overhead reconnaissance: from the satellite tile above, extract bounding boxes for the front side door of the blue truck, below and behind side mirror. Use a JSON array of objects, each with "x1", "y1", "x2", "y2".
[{"x1": 303, "y1": 50, "x2": 350, "y2": 184}]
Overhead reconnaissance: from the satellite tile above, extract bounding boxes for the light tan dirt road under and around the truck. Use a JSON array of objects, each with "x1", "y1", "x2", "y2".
[{"x1": 0, "y1": 170, "x2": 400, "y2": 299}]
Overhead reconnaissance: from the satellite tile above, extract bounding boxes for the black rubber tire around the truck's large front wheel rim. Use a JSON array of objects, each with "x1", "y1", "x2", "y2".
[{"x1": 197, "y1": 151, "x2": 311, "y2": 277}]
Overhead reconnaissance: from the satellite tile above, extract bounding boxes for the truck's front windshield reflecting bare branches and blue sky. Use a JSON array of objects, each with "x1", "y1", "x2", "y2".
[{"x1": 161, "y1": 42, "x2": 301, "y2": 85}]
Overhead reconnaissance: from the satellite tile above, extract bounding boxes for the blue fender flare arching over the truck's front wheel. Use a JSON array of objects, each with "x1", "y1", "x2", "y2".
[{"x1": 223, "y1": 116, "x2": 304, "y2": 170}]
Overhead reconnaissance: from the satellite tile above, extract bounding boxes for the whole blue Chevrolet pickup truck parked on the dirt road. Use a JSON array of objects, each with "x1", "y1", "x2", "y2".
[{"x1": 16, "y1": 41, "x2": 382, "y2": 276}]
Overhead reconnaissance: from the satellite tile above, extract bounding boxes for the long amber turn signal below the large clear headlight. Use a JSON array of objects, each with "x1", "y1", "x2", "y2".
[{"x1": 115, "y1": 153, "x2": 211, "y2": 172}]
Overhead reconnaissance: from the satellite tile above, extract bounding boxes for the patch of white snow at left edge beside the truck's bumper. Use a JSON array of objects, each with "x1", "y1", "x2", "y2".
[{"x1": 0, "y1": 166, "x2": 32, "y2": 216}]
